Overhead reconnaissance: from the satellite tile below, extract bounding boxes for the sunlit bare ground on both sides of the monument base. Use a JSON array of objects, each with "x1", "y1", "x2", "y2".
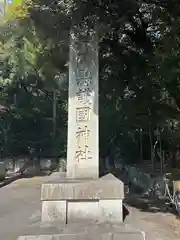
[{"x1": 0, "y1": 177, "x2": 180, "y2": 240}]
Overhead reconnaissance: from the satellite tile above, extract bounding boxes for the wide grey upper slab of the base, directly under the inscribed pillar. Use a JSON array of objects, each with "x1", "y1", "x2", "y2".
[{"x1": 41, "y1": 174, "x2": 124, "y2": 201}]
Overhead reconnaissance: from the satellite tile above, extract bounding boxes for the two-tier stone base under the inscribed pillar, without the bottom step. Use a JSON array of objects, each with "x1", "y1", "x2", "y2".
[{"x1": 41, "y1": 172, "x2": 124, "y2": 224}]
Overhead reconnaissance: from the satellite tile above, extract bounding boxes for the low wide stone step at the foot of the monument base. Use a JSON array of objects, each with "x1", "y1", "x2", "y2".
[{"x1": 18, "y1": 223, "x2": 145, "y2": 240}]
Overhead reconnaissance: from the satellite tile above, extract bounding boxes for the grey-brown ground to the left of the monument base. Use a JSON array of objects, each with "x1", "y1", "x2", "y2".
[{"x1": 0, "y1": 177, "x2": 43, "y2": 240}]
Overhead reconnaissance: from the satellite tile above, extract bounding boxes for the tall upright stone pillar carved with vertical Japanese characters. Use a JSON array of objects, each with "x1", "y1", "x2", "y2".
[{"x1": 67, "y1": 29, "x2": 99, "y2": 179}]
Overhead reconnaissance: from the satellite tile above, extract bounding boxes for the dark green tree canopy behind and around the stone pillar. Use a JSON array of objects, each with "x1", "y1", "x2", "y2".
[{"x1": 0, "y1": 0, "x2": 180, "y2": 166}]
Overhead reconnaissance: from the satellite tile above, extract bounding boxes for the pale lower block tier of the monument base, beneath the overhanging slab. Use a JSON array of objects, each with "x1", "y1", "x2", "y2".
[{"x1": 42, "y1": 199, "x2": 123, "y2": 224}]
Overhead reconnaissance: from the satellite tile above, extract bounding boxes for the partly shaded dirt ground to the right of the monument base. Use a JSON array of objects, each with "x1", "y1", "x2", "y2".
[{"x1": 125, "y1": 196, "x2": 180, "y2": 240}]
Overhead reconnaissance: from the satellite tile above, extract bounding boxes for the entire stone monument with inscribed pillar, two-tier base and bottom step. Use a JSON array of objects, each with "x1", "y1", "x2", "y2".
[{"x1": 19, "y1": 26, "x2": 144, "y2": 240}]
